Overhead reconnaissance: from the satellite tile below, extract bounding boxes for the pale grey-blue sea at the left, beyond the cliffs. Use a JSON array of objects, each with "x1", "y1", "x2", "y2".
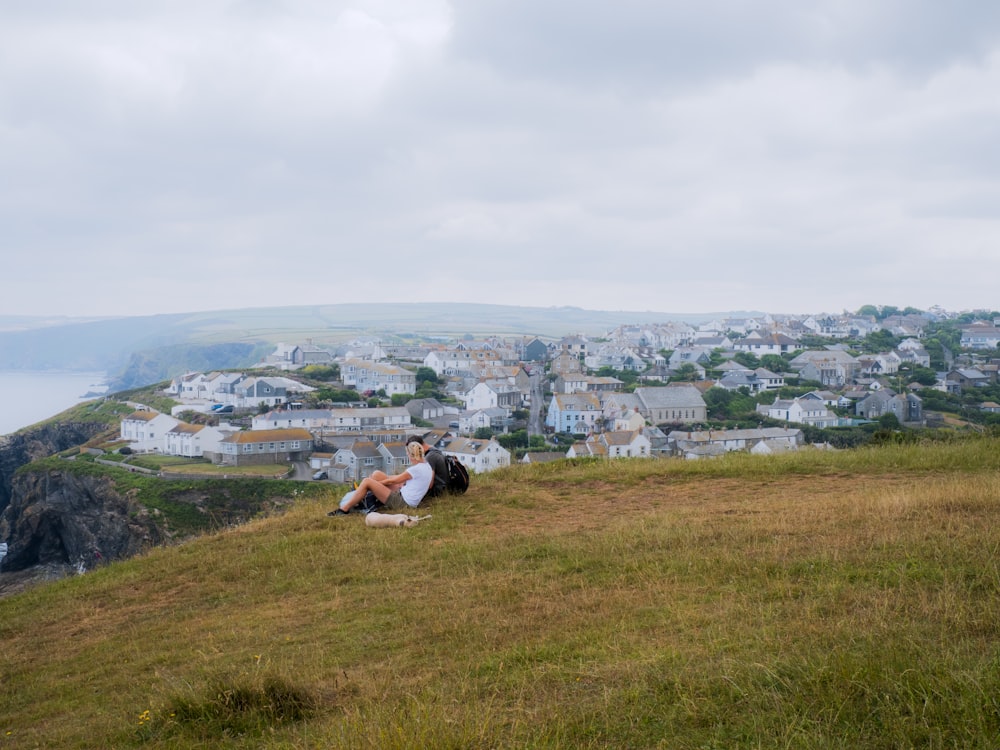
[{"x1": 0, "y1": 370, "x2": 107, "y2": 435}]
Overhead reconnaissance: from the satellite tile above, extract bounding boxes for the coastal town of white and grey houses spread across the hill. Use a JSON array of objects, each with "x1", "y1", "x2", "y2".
[{"x1": 113, "y1": 311, "x2": 1000, "y2": 482}]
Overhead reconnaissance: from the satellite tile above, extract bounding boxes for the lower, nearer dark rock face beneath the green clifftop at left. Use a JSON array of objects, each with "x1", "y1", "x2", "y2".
[{"x1": 0, "y1": 470, "x2": 166, "y2": 572}]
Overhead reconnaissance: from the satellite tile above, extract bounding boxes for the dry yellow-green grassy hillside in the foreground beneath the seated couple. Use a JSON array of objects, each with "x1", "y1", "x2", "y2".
[{"x1": 0, "y1": 439, "x2": 1000, "y2": 749}]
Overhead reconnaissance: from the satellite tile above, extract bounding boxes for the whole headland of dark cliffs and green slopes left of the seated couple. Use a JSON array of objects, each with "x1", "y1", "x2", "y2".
[{"x1": 0, "y1": 422, "x2": 302, "y2": 596}]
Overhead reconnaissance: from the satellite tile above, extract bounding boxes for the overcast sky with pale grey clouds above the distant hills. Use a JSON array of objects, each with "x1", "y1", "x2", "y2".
[{"x1": 0, "y1": 0, "x2": 1000, "y2": 316}]
